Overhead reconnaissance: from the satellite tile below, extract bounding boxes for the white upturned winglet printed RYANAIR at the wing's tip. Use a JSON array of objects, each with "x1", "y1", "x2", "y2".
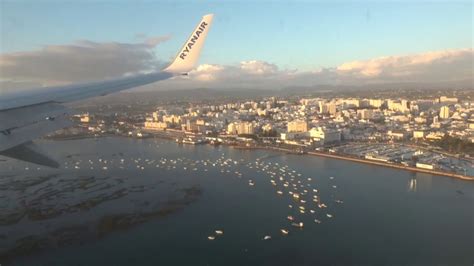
[{"x1": 163, "y1": 14, "x2": 214, "y2": 74}]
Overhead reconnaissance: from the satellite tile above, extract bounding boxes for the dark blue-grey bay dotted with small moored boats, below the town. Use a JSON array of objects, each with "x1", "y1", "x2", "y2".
[{"x1": 0, "y1": 137, "x2": 474, "y2": 266}]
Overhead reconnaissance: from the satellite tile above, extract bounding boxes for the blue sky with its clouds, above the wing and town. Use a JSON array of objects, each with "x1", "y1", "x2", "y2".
[{"x1": 0, "y1": 0, "x2": 473, "y2": 90}]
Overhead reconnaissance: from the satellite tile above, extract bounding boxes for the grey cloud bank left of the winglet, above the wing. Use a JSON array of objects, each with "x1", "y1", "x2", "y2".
[{"x1": 0, "y1": 36, "x2": 169, "y2": 85}]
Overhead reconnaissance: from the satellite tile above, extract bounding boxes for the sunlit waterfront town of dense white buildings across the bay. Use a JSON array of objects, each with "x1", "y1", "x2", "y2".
[{"x1": 52, "y1": 89, "x2": 474, "y2": 179}]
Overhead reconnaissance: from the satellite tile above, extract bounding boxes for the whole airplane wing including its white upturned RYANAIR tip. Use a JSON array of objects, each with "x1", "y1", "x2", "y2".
[{"x1": 0, "y1": 14, "x2": 213, "y2": 167}]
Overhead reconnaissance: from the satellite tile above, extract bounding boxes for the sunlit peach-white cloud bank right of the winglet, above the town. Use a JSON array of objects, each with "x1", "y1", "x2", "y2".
[{"x1": 180, "y1": 48, "x2": 474, "y2": 88}]
